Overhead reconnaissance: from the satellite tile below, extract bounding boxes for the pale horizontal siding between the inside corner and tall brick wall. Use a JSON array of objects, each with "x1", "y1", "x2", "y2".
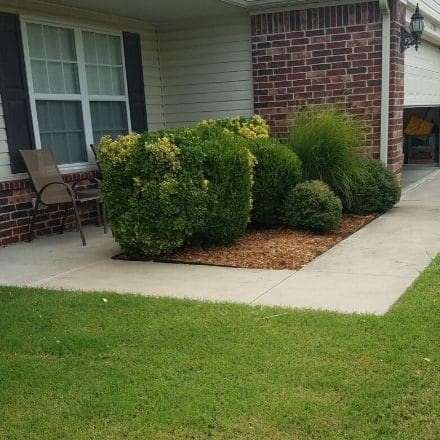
[{"x1": 159, "y1": 14, "x2": 253, "y2": 127}]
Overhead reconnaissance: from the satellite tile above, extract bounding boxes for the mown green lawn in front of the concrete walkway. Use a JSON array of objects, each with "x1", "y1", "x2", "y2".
[{"x1": 0, "y1": 257, "x2": 440, "y2": 440}]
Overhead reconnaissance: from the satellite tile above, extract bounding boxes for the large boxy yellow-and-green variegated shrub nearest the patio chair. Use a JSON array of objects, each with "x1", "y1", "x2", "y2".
[{"x1": 99, "y1": 130, "x2": 208, "y2": 255}]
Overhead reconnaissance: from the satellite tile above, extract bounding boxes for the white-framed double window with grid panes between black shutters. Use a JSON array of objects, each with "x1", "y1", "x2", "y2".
[{"x1": 22, "y1": 21, "x2": 130, "y2": 165}]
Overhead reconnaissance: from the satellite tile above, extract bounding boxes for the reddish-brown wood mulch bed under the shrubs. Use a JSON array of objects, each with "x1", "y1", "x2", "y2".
[{"x1": 164, "y1": 214, "x2": 375, "y2": 269}]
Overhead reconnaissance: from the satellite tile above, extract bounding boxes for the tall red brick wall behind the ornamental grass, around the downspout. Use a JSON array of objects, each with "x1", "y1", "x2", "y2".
[{"x1": 251, "y1": 0, "x2": 403, "y2": 170}]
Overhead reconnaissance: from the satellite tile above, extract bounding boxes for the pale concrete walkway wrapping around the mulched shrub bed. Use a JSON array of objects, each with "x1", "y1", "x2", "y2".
[{"x1": 0, "y1": 169, "x2": 440, "y2": 314}]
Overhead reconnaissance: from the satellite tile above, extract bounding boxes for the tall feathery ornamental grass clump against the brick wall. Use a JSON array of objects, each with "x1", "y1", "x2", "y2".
[{"x1": 289, "y1": 106, "x2": 365, "y2": 209}]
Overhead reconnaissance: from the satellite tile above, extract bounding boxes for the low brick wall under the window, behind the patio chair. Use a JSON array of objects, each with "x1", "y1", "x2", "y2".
[{"x1": 0, "y1": 171, "x2": 97, "y2": 246}]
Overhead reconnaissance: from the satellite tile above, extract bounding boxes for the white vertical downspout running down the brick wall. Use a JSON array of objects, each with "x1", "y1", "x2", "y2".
[{"x1": 379, "y1": 0, "x2": 391, "y2": 165}]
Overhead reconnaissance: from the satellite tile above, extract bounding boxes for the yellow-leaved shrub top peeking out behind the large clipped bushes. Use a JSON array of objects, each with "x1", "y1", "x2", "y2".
[{"x1": 199, "y1": 115, "x2": 269, "y2": 139}]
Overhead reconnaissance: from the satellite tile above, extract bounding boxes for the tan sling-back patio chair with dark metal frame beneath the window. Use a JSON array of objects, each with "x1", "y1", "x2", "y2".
[{"x1": 19, "y1": 148, "x2": 107, "y2": 246}]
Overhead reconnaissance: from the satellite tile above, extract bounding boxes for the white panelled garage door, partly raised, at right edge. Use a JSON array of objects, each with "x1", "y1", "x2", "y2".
[{"x1": 405, "y1": 41, "x2": 440, "y2": 107}]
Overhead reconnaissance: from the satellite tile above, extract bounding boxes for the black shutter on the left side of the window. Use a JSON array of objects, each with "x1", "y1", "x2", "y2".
[{"x1": 0, "y1": 12, "x2": 35, "y2": 173}]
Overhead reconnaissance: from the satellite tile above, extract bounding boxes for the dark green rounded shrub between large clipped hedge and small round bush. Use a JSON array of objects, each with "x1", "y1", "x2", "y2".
[{"x1": 248, "y1": 139, "x2": 301, "y2": 226}]
